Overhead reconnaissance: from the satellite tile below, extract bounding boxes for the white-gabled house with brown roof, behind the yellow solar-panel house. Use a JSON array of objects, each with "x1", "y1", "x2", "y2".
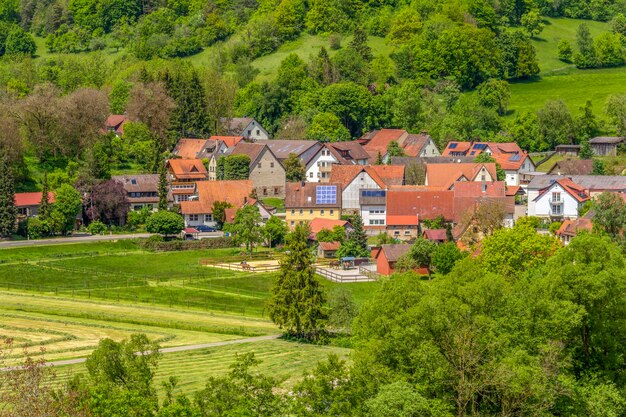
[{"x1": 306, "y1": 141, "x2": 369, "y2": 182}]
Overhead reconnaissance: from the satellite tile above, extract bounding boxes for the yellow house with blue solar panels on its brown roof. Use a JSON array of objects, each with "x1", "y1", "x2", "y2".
[{"x1": 285, "y1": 182, "x2": 341, "y2": 229}]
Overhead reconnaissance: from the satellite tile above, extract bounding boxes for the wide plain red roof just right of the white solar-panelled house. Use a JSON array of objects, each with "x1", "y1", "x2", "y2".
[{"x1": 387, "y1": 189, "x2": 454, "y2": 226}]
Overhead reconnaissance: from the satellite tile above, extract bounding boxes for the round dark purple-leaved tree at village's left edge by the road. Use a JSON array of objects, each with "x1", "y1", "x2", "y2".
[{"x1": 85, "y1": 180, "x2": 130, "y2": 226}]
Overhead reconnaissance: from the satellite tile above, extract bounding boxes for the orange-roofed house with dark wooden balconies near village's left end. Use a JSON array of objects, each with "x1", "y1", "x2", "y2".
[{"x1": 167, "y1": 159, "x2": 208, "y2": 204}]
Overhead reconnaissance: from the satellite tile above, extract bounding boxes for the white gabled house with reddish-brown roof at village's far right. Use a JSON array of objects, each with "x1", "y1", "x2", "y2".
[{"x1": 528, "y1": 178, "x2": 591, "y2": 219}]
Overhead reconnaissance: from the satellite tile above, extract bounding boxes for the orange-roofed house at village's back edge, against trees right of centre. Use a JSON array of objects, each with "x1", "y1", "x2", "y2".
[{"x1": 361, "y1": 129, "x2": 440, "y2": 163}]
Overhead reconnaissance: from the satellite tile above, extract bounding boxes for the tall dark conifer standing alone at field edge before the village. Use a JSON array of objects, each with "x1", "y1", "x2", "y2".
[{"x1": 268, "y1": 224, "x2": 327, "y2": 340}]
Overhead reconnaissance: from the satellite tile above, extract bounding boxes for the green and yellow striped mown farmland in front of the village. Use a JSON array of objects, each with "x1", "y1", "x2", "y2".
[{"x1": 0, "y1": 241, "x2": 379, "y2": 392}]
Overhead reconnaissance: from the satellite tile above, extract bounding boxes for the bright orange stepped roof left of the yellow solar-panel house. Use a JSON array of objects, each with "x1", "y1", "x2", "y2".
[{"x1": 180, "y1": 180, "x2": 254, "y2": 214}]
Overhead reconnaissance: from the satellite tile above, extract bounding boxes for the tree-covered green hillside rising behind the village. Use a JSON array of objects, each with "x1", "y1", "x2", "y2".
[{"x1": 0, "y1": 0, "x2": 626, "y2": 189}]
